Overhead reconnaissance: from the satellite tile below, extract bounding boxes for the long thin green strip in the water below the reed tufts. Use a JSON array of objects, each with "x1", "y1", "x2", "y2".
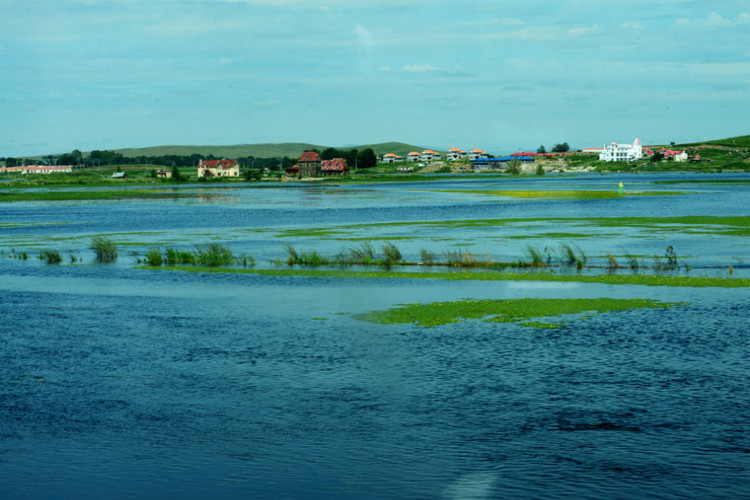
[{"x1": 139, "y1": 266, "x2": 750, "y2": 288}]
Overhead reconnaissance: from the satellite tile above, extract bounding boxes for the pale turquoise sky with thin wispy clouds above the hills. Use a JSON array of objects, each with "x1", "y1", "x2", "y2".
[{"x1": 0, "y1": 0, "x2": 750, "y2": 157}]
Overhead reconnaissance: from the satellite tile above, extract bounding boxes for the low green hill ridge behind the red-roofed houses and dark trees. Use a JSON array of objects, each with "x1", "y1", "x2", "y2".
[{"x1": 114, "y1": 142, "x2": 438, "y2": 159}]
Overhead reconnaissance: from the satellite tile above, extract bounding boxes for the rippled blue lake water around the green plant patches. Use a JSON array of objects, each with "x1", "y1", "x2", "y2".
[{"x1": 0, "y1": 174, "x2": 750, "y2": 499}]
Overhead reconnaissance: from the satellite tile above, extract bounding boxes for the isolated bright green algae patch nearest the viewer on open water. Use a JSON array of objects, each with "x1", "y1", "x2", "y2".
[{"x1": 354, "y1": 298, "x2": 684, "y2": 328}]
